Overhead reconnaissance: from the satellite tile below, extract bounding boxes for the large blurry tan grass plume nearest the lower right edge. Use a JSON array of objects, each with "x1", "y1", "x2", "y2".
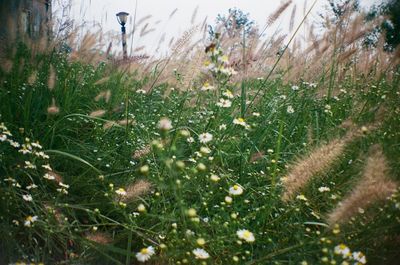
[{"x1": 328, "y1": 146, "x2": 397, "y2": 225}]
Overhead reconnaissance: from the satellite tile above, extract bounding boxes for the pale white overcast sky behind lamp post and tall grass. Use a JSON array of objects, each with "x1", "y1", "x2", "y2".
[{"x1": 55, "y1": 0, "x2": 381, "y2": 54}]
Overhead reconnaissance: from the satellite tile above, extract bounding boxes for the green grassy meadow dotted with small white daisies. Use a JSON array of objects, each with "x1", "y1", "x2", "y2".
[{"x1": 0, "y1": 2, "x2": 400, "y2": 265}]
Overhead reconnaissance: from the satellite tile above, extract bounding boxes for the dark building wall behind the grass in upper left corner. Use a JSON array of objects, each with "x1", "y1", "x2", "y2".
[{"x1": 0, "y1": 0, "x2": 51, "y2": 41}]
